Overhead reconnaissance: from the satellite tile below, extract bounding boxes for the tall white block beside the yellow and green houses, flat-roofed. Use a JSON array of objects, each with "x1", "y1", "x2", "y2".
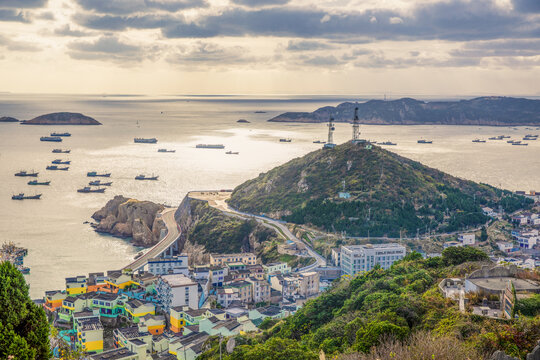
[{"x1": 156, "y1": 274, "x2": 199, "y2": 312}]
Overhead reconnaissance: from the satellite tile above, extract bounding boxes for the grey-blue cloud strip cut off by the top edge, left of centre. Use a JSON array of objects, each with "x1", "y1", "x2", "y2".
[{"x1": 76, "y1": 0, "x2": 208, "y2": 15}]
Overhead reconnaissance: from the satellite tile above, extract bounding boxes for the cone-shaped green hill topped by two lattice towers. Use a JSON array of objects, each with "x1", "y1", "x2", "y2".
[{"x1": 229, "y1": 142, "x2": 530, "y2": 237}]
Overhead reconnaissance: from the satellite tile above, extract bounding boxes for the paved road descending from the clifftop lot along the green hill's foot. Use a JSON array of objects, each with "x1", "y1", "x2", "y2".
[{"x1": 209, "y1": 200, "x2": 326, "y2": 272}]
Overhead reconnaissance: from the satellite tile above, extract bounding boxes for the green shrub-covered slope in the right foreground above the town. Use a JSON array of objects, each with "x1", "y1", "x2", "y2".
[{"x1": 201, "y1": 247, "x2": 540, "y2": 360}]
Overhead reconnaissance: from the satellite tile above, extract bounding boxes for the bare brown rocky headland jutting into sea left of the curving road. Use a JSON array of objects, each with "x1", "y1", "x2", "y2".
[{"x1": 92, "y1": 195, "x2": 166, "y2": 247}]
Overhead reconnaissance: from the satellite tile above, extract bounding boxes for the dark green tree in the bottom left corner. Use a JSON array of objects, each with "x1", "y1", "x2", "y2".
[{"x1": 0, "y1": 261, "x2": 51, "y2": 360}]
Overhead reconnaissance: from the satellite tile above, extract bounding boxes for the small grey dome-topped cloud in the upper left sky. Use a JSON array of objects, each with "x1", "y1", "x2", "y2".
[{"x1": 68, "y1": 36, "x2": 156, "y2": 62}]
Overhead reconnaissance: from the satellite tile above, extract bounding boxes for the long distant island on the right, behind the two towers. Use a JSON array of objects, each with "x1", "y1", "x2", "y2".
[{"x1": 268, "y1": 96, "x2": 540, "y2": 126}]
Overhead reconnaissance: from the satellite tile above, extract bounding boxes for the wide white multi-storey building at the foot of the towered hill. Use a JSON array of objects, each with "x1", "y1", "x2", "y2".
[{"x1": 341, "y1": 244, "x2": 406, "y2": 275}]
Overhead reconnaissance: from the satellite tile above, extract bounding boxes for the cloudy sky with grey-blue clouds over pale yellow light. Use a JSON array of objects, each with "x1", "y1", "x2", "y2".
[{"x1": 0, "y1": 0, "x2": 540, "y2": 96}]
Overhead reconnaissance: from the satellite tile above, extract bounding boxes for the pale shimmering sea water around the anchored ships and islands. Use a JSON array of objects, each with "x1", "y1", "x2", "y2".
[{"x1": 0, "y1": 94, "x2": 540, "y2": 298}]
